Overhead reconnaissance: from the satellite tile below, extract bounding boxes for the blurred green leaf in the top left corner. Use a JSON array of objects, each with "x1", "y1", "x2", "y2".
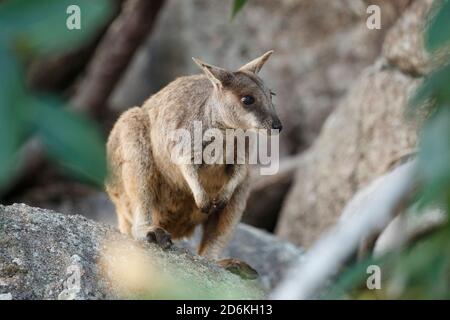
[{"x1": 0, "y1": 0, "x2": 112, "y2": 54}]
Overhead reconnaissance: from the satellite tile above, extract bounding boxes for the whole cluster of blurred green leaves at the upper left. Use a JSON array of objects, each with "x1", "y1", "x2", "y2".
[{"x1": 0, "y1": 0, "x2": 112, "y2": 187}]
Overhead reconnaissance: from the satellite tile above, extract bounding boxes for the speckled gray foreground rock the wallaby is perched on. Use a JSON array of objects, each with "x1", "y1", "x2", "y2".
[{"x1": 0, "y1": 204, "x2": 265, "y2": 299}]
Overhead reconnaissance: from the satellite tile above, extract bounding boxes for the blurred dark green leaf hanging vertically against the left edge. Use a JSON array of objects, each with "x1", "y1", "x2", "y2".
[{"x1": 0, "y1": 47, "x2": 26, "y2": 187}]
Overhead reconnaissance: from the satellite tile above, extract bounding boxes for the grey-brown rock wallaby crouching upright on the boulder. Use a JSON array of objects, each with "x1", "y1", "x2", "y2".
[{"x1": 106, "y1": 51, "x2": 281, "y2": 276}]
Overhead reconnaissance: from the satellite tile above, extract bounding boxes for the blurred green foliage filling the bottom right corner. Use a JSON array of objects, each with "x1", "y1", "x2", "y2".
[{"x1": 323, "y1": 226, "x2": 450, "y2": 299}]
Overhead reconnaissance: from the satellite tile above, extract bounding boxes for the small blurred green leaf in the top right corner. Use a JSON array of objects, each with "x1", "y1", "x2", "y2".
[{"x1": 425, "y1": 0, "x2": 450, "y2": 52}]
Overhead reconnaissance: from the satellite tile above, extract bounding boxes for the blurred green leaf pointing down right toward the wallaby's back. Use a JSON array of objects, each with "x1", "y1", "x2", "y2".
[{"x1": 31, "y1": 99, "x2": 106, "y2": 186}]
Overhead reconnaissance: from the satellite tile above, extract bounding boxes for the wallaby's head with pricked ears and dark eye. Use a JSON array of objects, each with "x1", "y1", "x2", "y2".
[{"x1": 193, "y1": 51, "x2": 282, "y2": 130}]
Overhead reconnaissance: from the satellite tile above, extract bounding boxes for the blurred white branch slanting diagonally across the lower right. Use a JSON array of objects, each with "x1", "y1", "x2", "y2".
[{"x1": 270, "y1": 161, "x2": 417, "y2": 299}]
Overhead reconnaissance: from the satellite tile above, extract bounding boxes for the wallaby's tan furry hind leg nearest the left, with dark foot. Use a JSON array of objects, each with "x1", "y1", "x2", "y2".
[{"x1": 108, "y1": 108, "x2": 170, "y2": 247}]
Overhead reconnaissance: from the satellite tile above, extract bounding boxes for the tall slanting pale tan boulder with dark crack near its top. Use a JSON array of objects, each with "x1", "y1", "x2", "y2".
[{"x1": 276, "y1": 0, "x2": 432, "y2": 246}]
